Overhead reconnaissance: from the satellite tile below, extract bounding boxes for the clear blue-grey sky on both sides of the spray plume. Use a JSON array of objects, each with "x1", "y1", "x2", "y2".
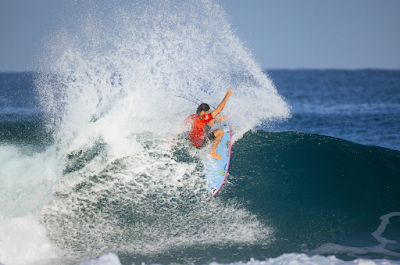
[{"x1": 0, "y1": 0, "x2": 400, "y2": 72}]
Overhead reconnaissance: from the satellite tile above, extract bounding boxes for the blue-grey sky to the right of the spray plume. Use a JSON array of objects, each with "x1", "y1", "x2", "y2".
[{"x1": 218, "y1": 0, "x2": 400, "y2": 69}]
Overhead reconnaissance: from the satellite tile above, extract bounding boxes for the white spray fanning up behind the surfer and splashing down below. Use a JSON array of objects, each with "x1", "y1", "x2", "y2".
[{"x1": 2, "y1": 0, "x2": 290, "y2": 260}]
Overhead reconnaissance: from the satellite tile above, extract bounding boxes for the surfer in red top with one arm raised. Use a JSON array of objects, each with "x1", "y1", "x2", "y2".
[{"x1": 185, "y1": 88, "x2": 232, "y2": 160}]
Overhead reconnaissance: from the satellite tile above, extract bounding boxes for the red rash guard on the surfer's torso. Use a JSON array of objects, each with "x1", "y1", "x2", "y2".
[{"x1": 185, "y1": 114, "x2": 213, "y2": 147}]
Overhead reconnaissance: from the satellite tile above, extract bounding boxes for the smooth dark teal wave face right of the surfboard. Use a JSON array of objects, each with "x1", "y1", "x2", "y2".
[{"x1": 227, "y1": 131, "x2": 400, "y2": 260}]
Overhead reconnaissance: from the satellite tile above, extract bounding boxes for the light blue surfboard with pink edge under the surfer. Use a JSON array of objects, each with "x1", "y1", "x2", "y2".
[{"x1": 205, "y1": 116, "x2": 232, "y2": 197}]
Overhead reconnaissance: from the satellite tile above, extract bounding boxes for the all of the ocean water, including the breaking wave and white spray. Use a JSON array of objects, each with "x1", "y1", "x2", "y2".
[{"x1": 0, "y1": 0, "x2": 400, "y2": 265}]
